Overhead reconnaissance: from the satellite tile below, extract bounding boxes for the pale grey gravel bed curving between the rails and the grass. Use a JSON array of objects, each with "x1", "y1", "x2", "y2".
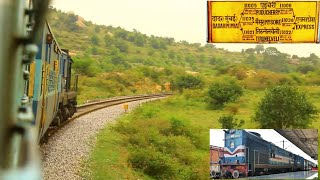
[{"x1": 40, "y1": 98, "x2": 161, "y2": 180}]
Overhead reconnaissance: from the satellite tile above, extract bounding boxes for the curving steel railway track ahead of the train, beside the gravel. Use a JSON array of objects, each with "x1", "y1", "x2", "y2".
[{"x1": 44, "y1": 93, "x2": 172, "y2": 145}]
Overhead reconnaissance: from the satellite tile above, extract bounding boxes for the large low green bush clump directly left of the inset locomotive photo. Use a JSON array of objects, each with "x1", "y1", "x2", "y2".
[{"x1": 113, "y1": 113, "x2": 208, "y2": 179}]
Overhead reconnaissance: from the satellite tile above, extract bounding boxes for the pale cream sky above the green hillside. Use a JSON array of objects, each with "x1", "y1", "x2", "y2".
[{"x1": 52, "y1": 0, "x2": 320, "y2": 56}]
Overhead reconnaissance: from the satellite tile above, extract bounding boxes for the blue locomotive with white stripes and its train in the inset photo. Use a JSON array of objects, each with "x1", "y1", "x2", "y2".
[{"x1": 210, "y1": 129, "x2": 316, "y2": 178}]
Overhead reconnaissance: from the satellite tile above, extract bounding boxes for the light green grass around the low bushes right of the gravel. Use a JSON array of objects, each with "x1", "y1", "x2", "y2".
[{"x1": 85, "y1": 87, "x2": 320, "y2": 179}]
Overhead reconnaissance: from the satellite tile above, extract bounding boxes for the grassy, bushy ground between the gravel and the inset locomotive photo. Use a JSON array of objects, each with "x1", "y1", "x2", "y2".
[{"x1": 84, "y1": 87, "x2": 320, "y2": 179}]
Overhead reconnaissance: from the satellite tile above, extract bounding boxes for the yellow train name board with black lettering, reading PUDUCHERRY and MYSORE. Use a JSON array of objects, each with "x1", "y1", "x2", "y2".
[{"x1": 208, "y1": 1, "x2": 319, "y2": 43}]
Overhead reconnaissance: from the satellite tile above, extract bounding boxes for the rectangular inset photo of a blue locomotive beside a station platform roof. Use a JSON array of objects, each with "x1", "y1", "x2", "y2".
[{"x1": 210, "y1": 129, "x2": 318, "y2": 179}]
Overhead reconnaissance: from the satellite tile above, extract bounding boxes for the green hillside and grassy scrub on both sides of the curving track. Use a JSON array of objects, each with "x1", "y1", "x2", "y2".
[{"x1": 49, "y1": 6, "x2": 320, "y2": 179}]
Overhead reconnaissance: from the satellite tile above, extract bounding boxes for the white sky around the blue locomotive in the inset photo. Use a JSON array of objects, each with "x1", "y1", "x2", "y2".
[{"x1": 210, "y1": 129, "x2": 318, "y2": 164}]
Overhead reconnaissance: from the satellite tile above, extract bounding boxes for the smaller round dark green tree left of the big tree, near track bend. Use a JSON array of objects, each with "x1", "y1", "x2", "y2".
[{"x1": 208, "y1": 81, "x2": 243, "y2": 109}]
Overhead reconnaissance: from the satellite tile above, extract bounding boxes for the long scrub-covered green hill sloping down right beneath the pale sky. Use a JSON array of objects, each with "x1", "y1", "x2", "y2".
[{"x1": 48, "y1": 9, "x2": 320, "y2": 101}]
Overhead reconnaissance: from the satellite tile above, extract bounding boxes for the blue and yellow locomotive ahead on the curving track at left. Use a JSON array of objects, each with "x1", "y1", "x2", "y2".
[{"x1": 27, "y1": 22, "x2": 78, "y2": 140}]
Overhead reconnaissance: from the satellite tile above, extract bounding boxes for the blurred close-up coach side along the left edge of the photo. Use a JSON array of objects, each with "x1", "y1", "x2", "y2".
[{"x1": 0, "y1": 0, "x2": 54, "y2": 179}]
